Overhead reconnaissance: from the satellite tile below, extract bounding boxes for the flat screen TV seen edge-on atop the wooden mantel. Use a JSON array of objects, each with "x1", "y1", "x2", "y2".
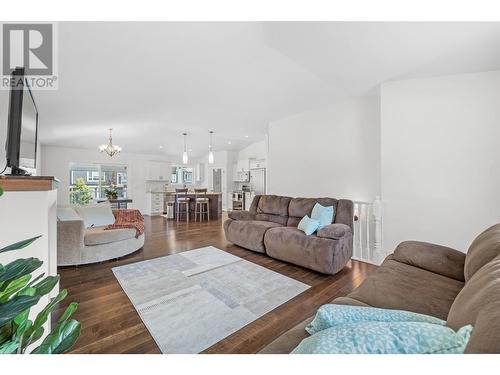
[{"x1": 5, "y1": 68, "x2": 38, "y2": 175}]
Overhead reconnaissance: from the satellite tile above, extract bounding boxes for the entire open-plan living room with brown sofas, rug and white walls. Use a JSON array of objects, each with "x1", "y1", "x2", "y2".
[{"x1": 0, "y1": 2, "x2": 500, "y2": 374}]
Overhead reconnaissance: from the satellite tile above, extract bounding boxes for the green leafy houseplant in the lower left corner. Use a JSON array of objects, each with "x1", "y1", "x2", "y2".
[{"x1": 0, "y1": 187, "x2": 81, "y2": 354}]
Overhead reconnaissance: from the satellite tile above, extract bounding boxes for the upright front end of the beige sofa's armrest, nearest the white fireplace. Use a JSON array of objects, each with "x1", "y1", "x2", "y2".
[{"x1": 57, "y1": 220, "x2": 86, "y2": 264}]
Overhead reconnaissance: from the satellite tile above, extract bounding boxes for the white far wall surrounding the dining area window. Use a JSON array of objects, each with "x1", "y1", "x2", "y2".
[{"x1": 42, "y1": 146, "x2": 174, "y2": 213}]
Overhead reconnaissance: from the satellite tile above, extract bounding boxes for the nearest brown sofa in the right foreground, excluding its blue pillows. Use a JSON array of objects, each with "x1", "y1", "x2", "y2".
[{"x1": 260, "y1": 224, "x2": 500, "y2": 353}]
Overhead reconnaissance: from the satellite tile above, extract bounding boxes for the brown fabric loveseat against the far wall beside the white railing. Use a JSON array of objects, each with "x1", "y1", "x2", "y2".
[{"x1": 224, "y1": 195, "x2": 353, "y2": 275}]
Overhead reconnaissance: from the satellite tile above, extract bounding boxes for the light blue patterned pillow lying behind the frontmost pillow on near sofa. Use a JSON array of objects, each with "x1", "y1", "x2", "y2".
[{"x1": 306, "y1": 304, "x2": 446, "y2": 335}]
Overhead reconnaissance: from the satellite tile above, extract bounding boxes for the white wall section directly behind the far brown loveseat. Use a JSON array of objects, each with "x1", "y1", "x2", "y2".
[{"x1": 267, "y1": 97, "x2": 380, "y2": 201}]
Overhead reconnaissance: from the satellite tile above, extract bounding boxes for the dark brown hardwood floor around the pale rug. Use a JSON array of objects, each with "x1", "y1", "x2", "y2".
[{"x1": 52, "y1": 216, "x2": 376, "y2": 353}]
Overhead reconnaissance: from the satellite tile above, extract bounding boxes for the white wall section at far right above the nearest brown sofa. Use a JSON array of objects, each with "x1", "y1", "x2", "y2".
[{"x1": 381, "y1": 72, "x2": 500, "y2": 252}]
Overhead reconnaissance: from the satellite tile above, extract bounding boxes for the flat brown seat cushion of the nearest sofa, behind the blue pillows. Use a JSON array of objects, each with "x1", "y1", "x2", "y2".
[{"x1": 348, "y1": 255, "x2": 464, "y2": 320}]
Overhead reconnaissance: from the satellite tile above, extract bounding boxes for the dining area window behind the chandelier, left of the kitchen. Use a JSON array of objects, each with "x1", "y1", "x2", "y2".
[{"x1": 69, "y1": 163, "x2": 127, "y2": 204}]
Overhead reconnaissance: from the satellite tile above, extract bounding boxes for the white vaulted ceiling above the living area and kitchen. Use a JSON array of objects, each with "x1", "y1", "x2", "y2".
[{"x1": 27, "y1": 22, "x2": 500, "y2": 157}]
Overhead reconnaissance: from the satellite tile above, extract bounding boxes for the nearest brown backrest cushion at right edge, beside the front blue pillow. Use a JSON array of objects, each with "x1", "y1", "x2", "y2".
[{"x1": 447, "y1": 256, "x2": 500, "y2": 353}]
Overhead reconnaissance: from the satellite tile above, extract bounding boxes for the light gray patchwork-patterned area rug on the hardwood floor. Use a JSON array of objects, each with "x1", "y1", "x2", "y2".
[{"x1": 113, "y1": 246, "x2": 309, "y2": 353}]
